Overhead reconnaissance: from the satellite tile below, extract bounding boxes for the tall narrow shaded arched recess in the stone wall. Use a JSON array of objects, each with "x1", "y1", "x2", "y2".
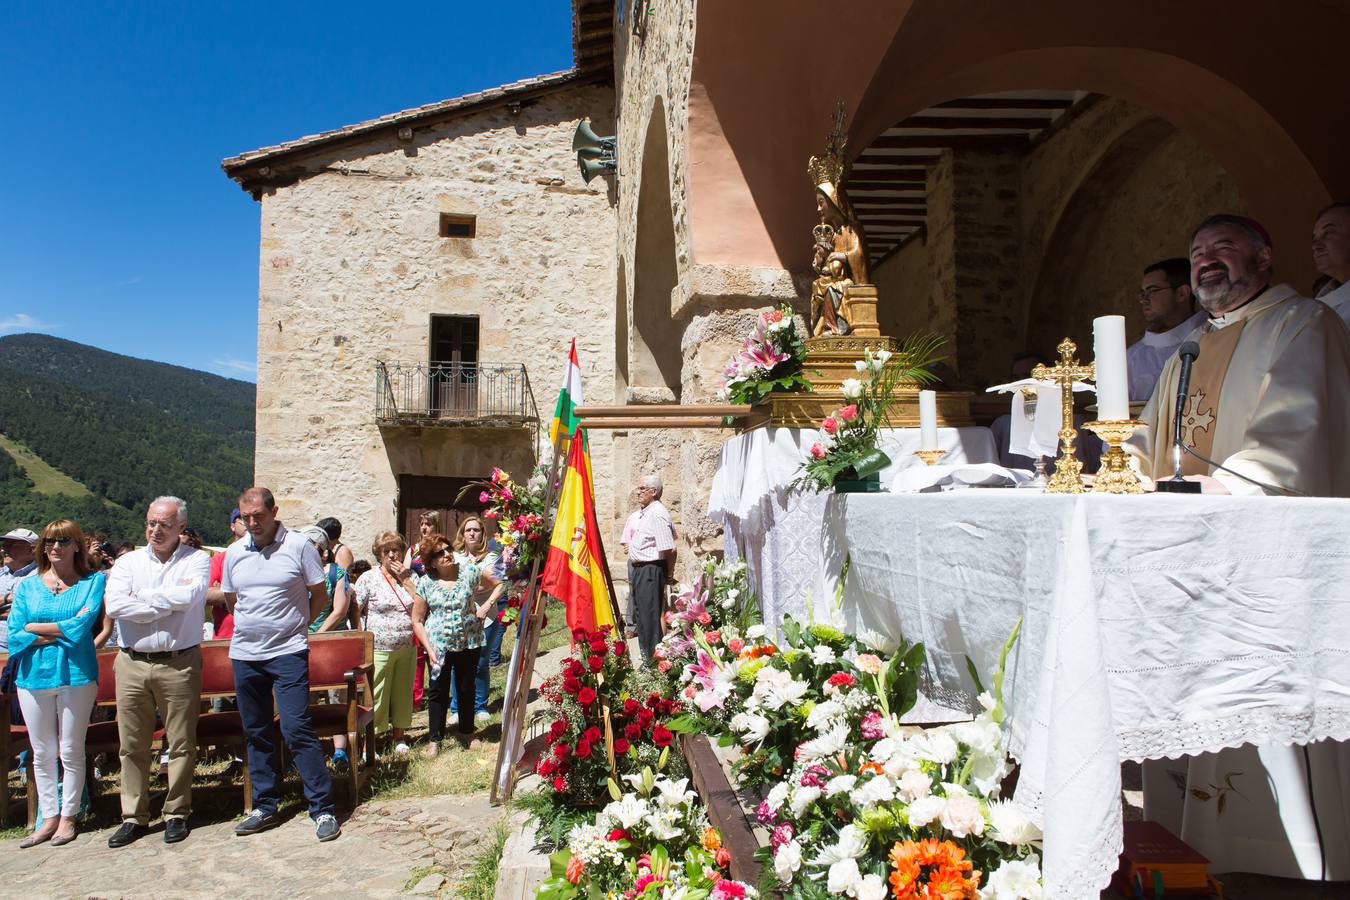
[{"x1": 628, "y1": 97, "x2": 682, "y2": 401}]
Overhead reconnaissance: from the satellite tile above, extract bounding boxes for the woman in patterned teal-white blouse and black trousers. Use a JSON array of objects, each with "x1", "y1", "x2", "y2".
[{"x1": 413, "y1": 534, "x2": 497, "y2": 756}]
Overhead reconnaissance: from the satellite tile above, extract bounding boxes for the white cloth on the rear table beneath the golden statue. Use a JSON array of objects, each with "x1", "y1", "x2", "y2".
[{"x1": 707, "y1": 428, "x2": 999, "y2": 630}]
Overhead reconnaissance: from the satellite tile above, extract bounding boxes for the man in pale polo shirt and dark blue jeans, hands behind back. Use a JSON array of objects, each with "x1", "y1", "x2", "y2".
[{"x1": 220, "y1": 487, "x2": 342, "y2": 841}]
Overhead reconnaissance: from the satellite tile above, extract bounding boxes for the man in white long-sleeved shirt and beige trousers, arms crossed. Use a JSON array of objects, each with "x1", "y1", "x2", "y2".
[{"x1": 104, "y1": 497, "x2": 211, "y2": 847}]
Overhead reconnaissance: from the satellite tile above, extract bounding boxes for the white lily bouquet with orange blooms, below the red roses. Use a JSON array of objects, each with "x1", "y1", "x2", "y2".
[{"x1": 535, "y1": 769, "x2": 757, "y2": 900}]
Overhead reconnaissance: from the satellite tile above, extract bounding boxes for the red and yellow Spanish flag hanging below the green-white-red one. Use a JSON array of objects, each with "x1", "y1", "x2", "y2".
[{"x1": 540, "y1": 428, "x2": 614, "y2": 630}]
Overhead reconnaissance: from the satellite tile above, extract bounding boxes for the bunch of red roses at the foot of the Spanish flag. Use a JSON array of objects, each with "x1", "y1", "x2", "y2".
[{"x1": 535, "y1": 625, "x2": 684, "y2": 807}]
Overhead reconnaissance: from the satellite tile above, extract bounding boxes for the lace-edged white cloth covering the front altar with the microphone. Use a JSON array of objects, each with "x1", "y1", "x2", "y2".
[{"x1": 821, "y1": 490, "x2": 1350, "y2": 897}]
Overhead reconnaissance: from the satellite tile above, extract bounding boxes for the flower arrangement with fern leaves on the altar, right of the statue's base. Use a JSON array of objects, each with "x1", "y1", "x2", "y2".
[{"x1": 792, "y1": 335, "x2": 942, "y2": 491}]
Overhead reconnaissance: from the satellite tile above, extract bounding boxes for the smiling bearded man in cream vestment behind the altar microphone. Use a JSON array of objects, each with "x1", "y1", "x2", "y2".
[{"x1": 1126, "y1": 216, "x2": 1350, "y2": 497}]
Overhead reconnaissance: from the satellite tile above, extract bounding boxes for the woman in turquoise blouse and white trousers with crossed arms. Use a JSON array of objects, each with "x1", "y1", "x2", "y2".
[{"x1": 8, "y1": 519, "x2": 104, "y2": 847}]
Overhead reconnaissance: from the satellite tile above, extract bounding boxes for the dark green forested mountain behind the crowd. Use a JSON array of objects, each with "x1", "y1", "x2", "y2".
[{"x1": 0, "y1": 335, "x2": 255, "y2": 544}]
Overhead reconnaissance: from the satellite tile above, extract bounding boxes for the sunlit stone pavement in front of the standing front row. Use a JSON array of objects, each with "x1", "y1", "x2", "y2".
[{"x1": 0, "y1": 795, "x2": 502, "y2": 900}]
